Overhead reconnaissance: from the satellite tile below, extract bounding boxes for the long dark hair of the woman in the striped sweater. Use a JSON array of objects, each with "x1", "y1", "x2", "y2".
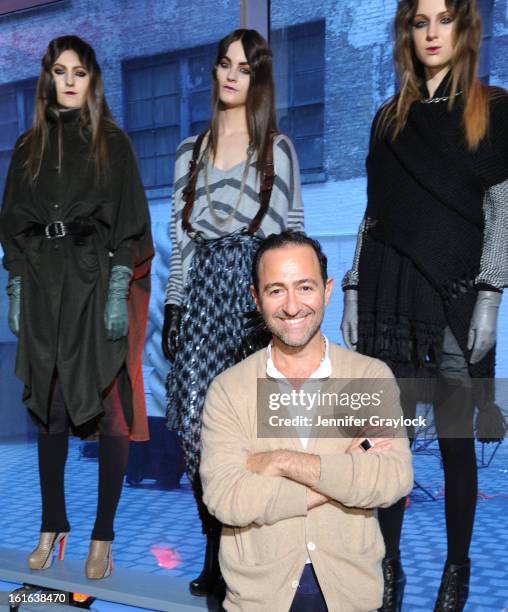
[{"x1": 208, "y1": 29, "x2": 277, "y2": 172}]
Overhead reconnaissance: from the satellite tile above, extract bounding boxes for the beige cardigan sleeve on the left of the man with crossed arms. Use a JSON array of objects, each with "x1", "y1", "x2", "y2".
[{"x1": 200, "y1": 380, "x2": 307, "y2": 527}]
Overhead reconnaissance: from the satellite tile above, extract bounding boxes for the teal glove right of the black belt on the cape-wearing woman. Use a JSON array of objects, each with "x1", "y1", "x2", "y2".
[{"x1": 104, "y1": 266, "x2": 132, "y2": 341}]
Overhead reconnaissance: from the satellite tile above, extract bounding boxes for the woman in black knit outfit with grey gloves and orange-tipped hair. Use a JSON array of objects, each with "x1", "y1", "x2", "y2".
[{"x1": 342, "y1": 0, "x2": 508, "y2": 612}]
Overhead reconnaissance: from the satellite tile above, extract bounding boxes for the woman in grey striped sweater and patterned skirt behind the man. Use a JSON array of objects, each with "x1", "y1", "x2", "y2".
[{"x1": 162, "y1": 30, "x2": 303, "y2": 595}]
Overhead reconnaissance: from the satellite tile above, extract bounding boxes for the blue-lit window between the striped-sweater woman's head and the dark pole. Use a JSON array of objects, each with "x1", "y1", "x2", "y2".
[{"x1": 271, "y1": 21, "x2": 325, "y2": 182}]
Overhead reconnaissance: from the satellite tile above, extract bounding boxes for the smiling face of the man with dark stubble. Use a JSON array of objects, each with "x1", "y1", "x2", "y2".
[{"x1": 252, "y1": 245, "x2": 333, "y2": 347}]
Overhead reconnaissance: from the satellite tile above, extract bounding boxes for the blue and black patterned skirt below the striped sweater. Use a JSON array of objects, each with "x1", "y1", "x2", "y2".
[{"x1": 166, "y1": 232, "x2": 259, "y2": 482}]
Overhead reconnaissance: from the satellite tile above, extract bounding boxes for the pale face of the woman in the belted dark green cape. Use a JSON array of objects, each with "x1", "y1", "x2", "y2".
[{"x1": 51, "y1": 49, "x2": 90, "y2": 108}]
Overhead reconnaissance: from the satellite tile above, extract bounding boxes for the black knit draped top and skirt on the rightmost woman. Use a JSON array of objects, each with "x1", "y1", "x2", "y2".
[{"x1": 358, "y1": 77, "x2": 508, "y2": 390}]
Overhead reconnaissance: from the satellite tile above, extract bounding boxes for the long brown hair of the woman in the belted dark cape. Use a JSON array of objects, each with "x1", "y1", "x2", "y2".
[{"x1": 24, "y1": 36, "x2": 115, "y2": 181}]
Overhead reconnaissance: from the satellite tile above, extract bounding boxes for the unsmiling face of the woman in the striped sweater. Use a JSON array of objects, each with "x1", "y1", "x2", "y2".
[{"x1": 216, "y1": 40, "x2": 251, "y2": 108}]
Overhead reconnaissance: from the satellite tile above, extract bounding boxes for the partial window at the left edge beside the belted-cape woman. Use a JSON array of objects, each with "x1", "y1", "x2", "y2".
[{"x1": 0, "y1": 79, "x2": 37, "y2": 198}]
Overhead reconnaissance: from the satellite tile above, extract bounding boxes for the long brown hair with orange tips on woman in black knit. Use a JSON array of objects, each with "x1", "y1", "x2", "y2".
[{"x1": 379, "y1": 0, "x2": 489, "y2": 150}]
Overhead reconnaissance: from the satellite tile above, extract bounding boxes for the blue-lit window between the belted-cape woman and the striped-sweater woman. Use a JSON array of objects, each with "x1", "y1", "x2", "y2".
[{"x1": 123, "y1": 45, "x2": 215, "y2": 188}]
